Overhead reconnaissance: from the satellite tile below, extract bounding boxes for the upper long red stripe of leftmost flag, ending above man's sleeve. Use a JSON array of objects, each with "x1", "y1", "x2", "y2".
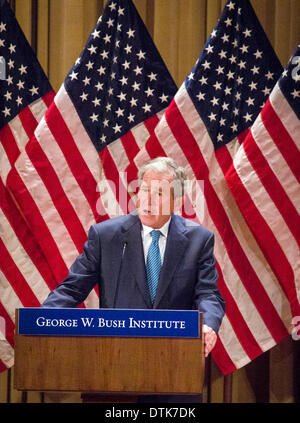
[{"x1": 0, "y1": 178, "x2": 57, "y2": 289}]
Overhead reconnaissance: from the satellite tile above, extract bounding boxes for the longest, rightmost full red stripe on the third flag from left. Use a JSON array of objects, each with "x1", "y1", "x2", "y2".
[{"x1": 166, "y1": 102, "x2": 287, "y2": 342}]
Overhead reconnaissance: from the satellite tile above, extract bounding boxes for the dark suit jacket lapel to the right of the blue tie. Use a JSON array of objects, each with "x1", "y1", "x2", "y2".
[{"x1": 153, "y1": 215, "x2": 188, "y2": 308}]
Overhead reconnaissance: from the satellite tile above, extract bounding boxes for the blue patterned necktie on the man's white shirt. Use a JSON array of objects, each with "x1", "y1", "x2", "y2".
[{"x1": 146, "y1": 230, "x2": 161, "y2": 302}]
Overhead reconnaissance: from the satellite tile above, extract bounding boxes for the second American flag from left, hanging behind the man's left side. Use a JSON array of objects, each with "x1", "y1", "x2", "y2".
[{"x1": 8, "y1": 0, "x2": 177, "y2": 314}]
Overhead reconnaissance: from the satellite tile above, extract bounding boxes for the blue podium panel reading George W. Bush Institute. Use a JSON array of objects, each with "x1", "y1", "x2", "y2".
[{"x1": 18, "y1": 308, "x2": 200, "y2": 338}]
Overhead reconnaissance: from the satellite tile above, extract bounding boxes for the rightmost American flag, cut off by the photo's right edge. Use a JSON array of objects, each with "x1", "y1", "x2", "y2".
[{"x1": 225, "y1": 45, "x2": 300, "y2": 323}]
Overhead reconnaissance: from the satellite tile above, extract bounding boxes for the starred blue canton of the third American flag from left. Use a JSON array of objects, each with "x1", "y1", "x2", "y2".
[{"x1": 186, "y1": 0, "x2": 282, "y2": 149}]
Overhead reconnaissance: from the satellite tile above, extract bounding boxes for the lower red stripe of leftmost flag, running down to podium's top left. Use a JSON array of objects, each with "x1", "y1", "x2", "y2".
[{"x1": 0, "y1": 239, "x2": 40, "y2": 307}]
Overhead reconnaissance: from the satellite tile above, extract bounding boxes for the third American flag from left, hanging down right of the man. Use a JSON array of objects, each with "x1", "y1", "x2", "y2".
[{"x1": 135, "y1": 0, "x2": 292, "y2": 374}]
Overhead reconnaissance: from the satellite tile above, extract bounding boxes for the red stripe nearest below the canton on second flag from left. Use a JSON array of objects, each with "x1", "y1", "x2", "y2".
[{"x1": 45, "y1": 103, "x2": 99, "y2": 220}]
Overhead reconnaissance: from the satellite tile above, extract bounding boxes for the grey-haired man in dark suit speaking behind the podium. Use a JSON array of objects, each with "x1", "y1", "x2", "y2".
[{"x1": 42, "y1": 157, "x2": 225, "y2": 402}]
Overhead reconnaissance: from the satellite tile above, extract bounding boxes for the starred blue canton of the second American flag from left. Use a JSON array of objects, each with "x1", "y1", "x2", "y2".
[{"x1": 65, "y1": 0, "x2": 177, "y2": 151}]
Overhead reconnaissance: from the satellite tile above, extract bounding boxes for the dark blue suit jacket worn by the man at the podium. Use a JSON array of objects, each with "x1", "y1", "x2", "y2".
[{"x1": 42, "y1": 214, "x2": 225, "y2": 332}]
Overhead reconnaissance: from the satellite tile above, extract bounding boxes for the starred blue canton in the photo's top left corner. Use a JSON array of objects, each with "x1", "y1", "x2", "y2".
[{"x1": 0, "y1": 1, "x2": 52, "y2": 128}]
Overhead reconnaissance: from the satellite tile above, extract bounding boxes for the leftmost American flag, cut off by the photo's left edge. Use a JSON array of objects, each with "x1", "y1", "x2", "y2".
[{"x1": 0, "y1": 1, "x2": 57, "y2": 371}]
